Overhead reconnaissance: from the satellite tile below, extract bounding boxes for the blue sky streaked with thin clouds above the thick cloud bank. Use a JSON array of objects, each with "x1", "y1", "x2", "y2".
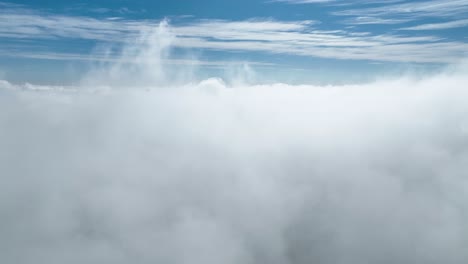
[{"x1": 0, "y1": 0, "x2": 468, "y2": 83}]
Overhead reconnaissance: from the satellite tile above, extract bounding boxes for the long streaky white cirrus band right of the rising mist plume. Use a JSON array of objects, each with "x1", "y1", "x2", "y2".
[{"x1": 169, "y1": 21, "x2": 468, "y2": 62}]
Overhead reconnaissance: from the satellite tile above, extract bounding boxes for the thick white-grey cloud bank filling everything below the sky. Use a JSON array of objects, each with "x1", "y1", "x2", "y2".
[{"x1": 0, "y1": 22, "x2": 468, "y2": 264}]
